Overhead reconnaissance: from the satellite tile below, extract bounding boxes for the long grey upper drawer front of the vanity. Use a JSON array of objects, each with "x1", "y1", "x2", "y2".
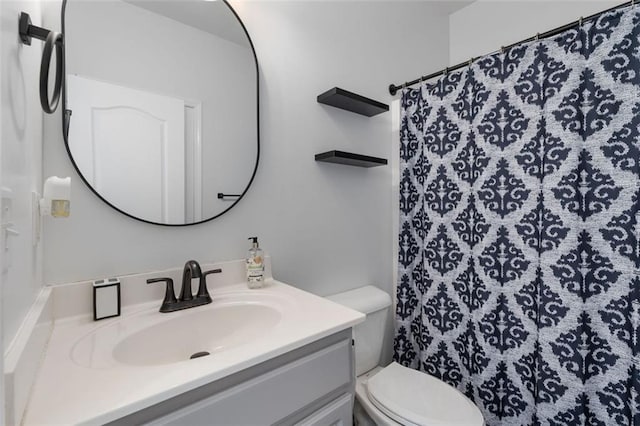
[{"x1": 149, "y1": 339, "x2": 353, "y2": 426}]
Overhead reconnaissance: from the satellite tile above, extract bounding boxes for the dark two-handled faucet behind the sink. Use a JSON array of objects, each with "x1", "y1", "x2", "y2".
[{"x1": 147, "y1": 260, "x2": 222, "y2": 312}]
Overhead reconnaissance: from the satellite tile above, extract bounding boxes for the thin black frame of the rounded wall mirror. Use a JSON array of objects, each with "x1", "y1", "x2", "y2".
[{"x1": 60, "y1": 0, "x2": 260, "y2": 227}]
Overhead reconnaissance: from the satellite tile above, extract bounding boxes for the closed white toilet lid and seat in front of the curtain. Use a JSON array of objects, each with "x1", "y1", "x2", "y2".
[{"x1": 367, "y1": 362, "x2": 484, "y2": 426}]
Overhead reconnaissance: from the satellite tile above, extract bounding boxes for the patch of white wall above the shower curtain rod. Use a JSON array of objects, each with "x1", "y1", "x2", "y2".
[{"x1": 450, "y1": 0, "x2": 621, "y2": 65}]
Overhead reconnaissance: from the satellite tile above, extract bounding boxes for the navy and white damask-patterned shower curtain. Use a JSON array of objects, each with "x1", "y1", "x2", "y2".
[{"x1": 394, "y1": 7, "x2": 640, "y2": 426}]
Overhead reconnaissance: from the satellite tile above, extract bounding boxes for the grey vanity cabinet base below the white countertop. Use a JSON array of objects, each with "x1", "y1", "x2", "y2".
[{"x1": 109, "y1": 329, "x2": 355, "y2": 426}]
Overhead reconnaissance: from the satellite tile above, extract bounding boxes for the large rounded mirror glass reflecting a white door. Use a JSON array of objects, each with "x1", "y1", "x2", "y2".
[{"x1": 62, "y1": 0, "x2": 260, "y2": 226}]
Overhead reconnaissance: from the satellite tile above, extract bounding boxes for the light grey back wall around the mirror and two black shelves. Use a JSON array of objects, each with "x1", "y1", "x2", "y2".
[{"x1": 44, "y1": 0, "x2": 447, "y2": 294}]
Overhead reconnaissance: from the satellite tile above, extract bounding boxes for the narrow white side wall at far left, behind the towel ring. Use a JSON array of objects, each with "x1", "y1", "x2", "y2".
[{"x1": 0, "y1": 0, "x2": 43, "y2": 349}]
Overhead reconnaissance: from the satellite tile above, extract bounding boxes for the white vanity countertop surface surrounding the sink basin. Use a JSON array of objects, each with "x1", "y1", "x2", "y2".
[{"x1": 23, "y1": 280, "x2": 364, "y2": 425}]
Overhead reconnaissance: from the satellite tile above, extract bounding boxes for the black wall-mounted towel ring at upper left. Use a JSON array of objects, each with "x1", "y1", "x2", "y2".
[{"x1": 18, "y1": 12, "x2": 64, "y2": 114}]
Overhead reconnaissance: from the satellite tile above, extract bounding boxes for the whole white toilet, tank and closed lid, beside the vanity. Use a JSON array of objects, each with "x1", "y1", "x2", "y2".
[{"x1": 327, "y1": 286, "x2": 485, "y2": 426}]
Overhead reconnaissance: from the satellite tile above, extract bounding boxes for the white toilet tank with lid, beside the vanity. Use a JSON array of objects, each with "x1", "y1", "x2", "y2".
[{"x1": 327, "y1": 285, "x2": 391, "y2": 376}]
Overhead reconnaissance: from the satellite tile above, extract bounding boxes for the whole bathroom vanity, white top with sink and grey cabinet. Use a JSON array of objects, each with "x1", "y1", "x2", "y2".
[{"x1": 15, "y1": 262, "x2": 364, "y2": 425}]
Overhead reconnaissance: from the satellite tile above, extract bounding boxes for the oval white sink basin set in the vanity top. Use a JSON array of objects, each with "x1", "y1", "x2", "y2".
[{"x1": 71, "y1": 293, "x2": 283, "y2": 369}]
